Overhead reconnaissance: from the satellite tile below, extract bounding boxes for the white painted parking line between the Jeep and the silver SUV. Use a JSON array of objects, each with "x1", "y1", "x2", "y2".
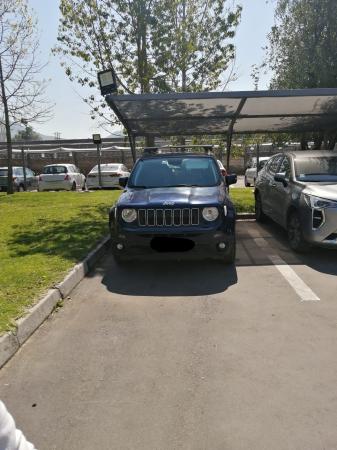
[{"x1": 248, "y1": 230, "x2": 320, "y2": 302}]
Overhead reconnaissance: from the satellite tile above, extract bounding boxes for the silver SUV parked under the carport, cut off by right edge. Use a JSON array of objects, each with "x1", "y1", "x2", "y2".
[{"x1": 255, "y1": 151, "x2": 337, "y2": 251}]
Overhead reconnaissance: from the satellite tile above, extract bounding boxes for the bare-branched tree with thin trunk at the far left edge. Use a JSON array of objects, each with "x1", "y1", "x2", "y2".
[{"x1": 0, "y1": 0, "x2": 51, "y2": 194}]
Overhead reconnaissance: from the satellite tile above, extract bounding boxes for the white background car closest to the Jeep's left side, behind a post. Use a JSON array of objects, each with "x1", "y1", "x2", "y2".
[{"x1": 87, "y1": 163, "x2": 130, "y2": 189}]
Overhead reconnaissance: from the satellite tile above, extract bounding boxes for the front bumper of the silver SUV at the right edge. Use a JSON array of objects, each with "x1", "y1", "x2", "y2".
[{"x1": 301, "y1": 207, "x2": 337, "y2": 249}]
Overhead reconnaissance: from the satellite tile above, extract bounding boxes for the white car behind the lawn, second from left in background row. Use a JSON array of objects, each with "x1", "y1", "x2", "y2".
[{"x1": 38, "y1": 164, "x2": 86, "y2": 191}]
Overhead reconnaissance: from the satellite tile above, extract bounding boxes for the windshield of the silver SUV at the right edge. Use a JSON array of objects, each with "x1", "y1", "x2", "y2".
[{"x1": 295, "y1": 156, "x2": 337, "y2": 182}]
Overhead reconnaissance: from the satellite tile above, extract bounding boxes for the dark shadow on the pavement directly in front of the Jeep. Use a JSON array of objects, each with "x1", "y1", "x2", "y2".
[{"x1": 96, "y1": 256, "x2": 237, "y2": 297}]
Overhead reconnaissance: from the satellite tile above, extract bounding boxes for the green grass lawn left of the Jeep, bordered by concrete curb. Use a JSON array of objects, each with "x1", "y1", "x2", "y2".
[{"x1": 0, "y1": 191, "x2": 120, "y2": 332}]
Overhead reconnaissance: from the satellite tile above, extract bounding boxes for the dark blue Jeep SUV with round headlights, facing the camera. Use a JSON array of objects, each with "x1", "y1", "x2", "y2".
[{"x1": 109, "y1": 152, "x2": 236, "y2": 263}]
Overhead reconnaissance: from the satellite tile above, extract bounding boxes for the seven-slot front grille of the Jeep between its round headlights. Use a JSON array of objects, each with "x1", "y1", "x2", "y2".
[{"x1": 138, "y1": 208, "x2": 199, "y2": 227}]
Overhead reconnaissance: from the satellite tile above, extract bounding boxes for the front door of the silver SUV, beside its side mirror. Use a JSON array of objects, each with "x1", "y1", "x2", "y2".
[{"x1": 270, "y1": 156, "x2": 291, "y2": 226}]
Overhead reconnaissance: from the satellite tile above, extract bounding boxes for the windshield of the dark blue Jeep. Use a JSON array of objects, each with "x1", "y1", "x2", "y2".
[{"x1": 129, "y1": 156, "x2": 221, "y2": 188}]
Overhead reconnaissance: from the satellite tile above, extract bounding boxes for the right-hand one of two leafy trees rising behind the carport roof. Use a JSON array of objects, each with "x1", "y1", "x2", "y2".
[{"x1": 151, "y1": 0, "x2": 241, "y2": 92}]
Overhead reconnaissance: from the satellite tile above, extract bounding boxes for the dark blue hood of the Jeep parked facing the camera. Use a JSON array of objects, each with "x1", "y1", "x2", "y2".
[{"x1": 118, "y1": 185, "x2": 226, "y2": 207}]
